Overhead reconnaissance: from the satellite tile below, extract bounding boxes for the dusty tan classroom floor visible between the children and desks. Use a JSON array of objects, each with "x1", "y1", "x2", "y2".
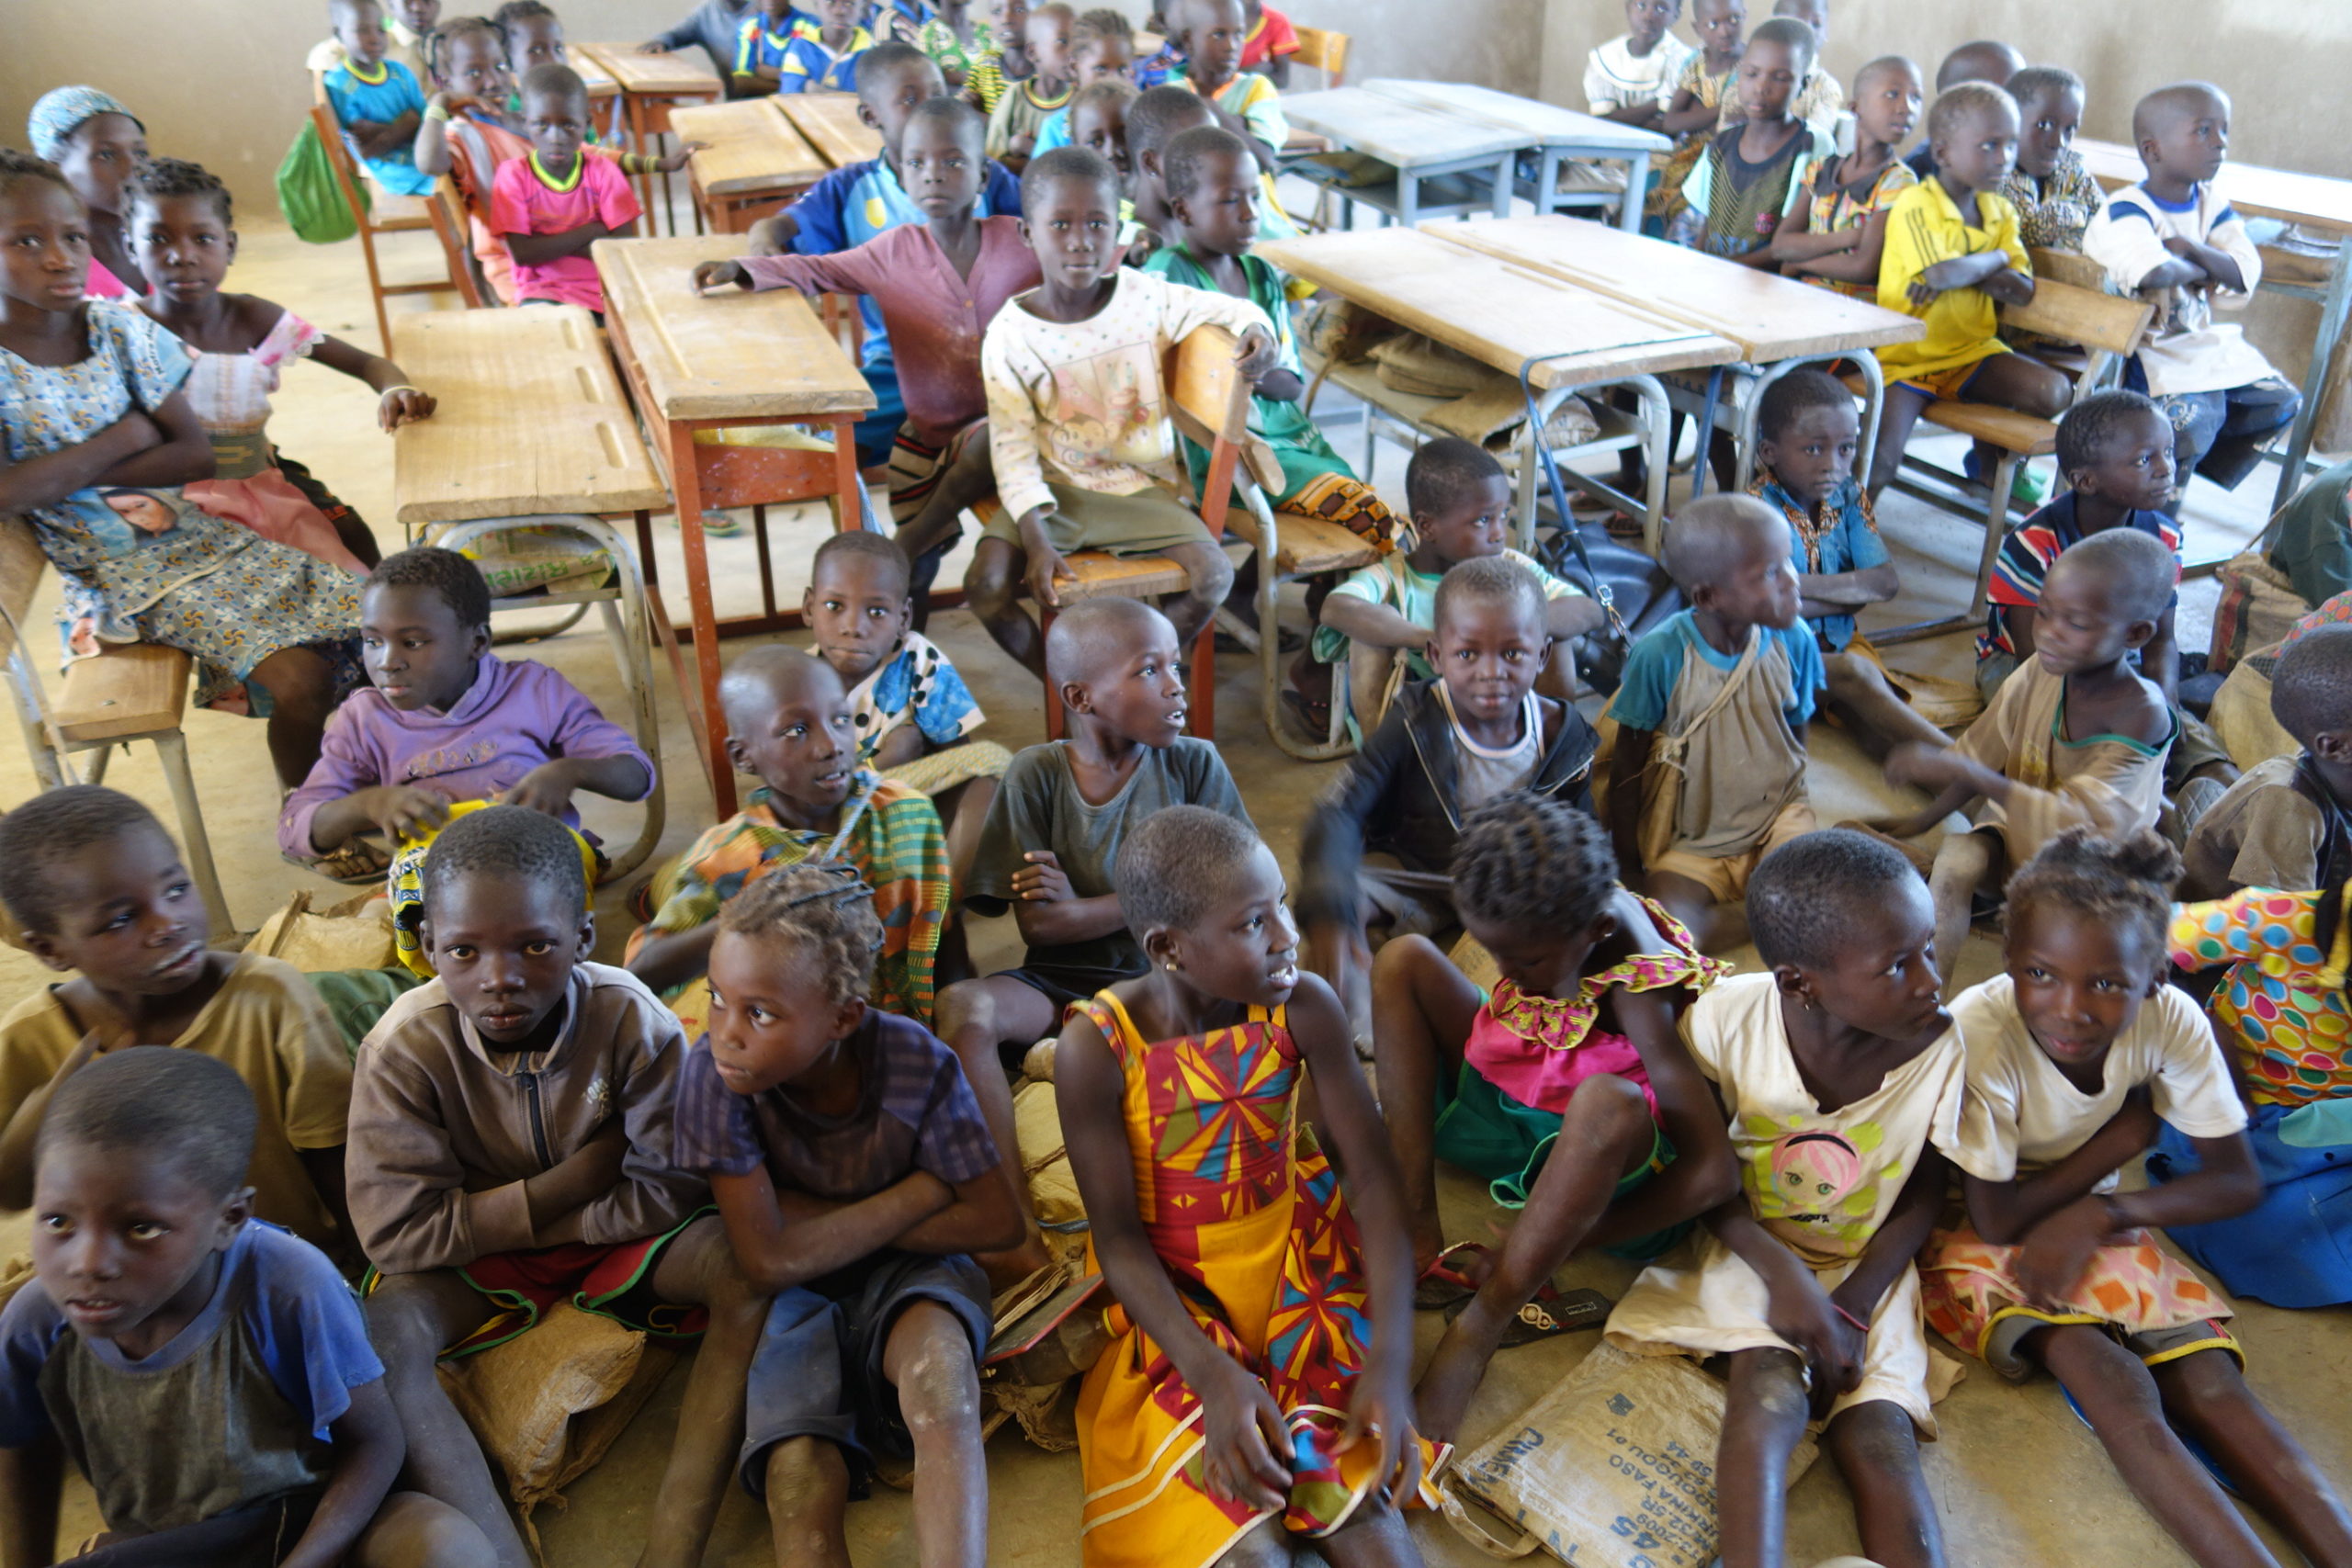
[{"x1": 0, "y1": 221, "x2": 2352, "y2": 1568}]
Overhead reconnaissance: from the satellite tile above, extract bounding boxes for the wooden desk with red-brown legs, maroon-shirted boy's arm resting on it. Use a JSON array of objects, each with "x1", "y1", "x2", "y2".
[{"x1": 591, "y1": 240, "x2": 875, "y2": 816}]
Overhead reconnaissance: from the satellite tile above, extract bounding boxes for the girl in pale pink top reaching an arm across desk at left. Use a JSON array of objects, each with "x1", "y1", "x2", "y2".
[{"x1": 130, "y1": 157, "x2": 433, "y2": 573}]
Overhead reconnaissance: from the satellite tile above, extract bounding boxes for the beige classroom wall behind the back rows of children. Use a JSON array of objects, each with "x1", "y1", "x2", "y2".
[{"x1": 0, "y1": 0, "x2": 2352, "y2": 217}]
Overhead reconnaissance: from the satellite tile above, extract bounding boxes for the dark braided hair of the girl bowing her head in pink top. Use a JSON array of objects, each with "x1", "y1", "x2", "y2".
[{"x1": 1453, "y1": 790, "x2": 1616, "y2": 936}]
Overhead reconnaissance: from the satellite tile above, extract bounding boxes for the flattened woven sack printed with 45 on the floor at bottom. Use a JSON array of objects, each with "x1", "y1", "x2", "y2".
[{"x1": 1440, "y1": 1345, "x2": 1815, "y2": 1568}]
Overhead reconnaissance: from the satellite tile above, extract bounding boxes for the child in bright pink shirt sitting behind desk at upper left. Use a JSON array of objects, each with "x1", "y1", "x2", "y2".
[{"x1": 489, "y1": 66, "x2": 644, "y2": 322}]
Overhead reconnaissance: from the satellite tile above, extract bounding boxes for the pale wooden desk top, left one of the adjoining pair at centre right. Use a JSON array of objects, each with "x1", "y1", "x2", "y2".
[{"x1": 1256, "y1": 228, "x2": 1740, "y2": 388}]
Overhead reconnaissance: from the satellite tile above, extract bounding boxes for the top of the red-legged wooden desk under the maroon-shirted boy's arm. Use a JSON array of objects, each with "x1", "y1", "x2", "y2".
[{"x1": 591, "y1": 235, "x2": 875, "y2": 423}]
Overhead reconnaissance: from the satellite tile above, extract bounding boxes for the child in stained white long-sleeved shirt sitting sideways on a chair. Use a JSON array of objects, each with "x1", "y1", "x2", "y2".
[{"x1": 965, "y1": 139, "x2": 1277, "y2": 674}]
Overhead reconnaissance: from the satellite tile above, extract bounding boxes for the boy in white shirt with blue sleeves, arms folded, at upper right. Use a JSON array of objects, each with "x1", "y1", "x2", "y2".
[{"x1": 2082, "y1": 83, "x2": 2302, "y2": 514}]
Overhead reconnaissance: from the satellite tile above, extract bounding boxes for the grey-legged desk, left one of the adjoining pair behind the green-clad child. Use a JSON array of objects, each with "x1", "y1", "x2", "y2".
[{"x1": 1256, "y1": 228, "x2": 1740, "y2": 552}]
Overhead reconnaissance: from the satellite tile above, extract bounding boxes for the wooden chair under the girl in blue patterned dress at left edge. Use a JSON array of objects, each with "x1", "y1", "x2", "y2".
[{"x1": 0, "y1": 517, "x2": 235, "y2": 938}]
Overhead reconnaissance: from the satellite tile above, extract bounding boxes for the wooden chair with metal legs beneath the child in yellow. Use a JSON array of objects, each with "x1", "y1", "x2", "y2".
[{"x1": 1849, "y1": 252, "x2": 2154, "y2": 647}]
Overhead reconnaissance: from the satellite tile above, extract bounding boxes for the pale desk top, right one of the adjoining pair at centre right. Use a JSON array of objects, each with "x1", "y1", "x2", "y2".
[{"x1": 1423, "y1": 214, "x2": 1927, "y2": 365}]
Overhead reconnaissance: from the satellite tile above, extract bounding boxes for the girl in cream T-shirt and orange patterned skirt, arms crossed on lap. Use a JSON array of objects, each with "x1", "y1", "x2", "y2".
[{"x1": 1919, "y1": 828, "x2": 2352, "y2": 1563}]
